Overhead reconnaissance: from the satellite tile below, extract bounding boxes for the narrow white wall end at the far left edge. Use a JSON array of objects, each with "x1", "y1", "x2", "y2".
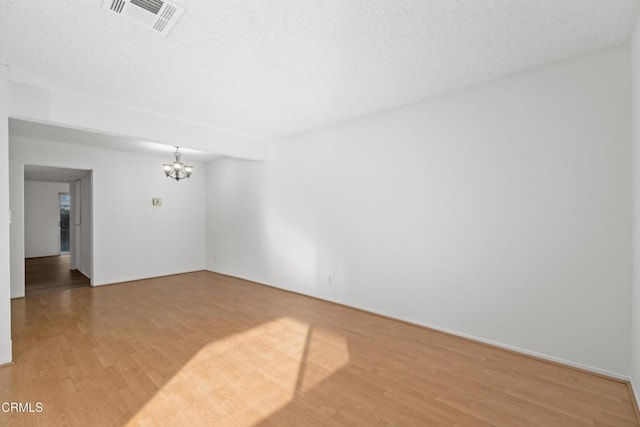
[{"x1": 0, "y1": 64, "x2": 12, "y2": 365}]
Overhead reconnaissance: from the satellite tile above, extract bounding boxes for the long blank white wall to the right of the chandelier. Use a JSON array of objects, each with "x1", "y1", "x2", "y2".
[{"x1": 207, "y1": 46, "x2": 631, "y2": 378}]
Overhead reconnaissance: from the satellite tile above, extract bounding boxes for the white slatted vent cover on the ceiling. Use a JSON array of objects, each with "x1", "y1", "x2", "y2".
[{"x1": 102, "y1": 0, "x2": 184, "y2": 34}]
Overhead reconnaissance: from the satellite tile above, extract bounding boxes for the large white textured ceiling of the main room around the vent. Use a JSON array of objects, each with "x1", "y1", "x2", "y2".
[{"x1": 0, "y1": 0, "x2": 639, "y2": 138}]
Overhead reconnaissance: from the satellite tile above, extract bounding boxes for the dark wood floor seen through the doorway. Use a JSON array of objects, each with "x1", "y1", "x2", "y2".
[{"x1": 24, "y1": 255, "x2": 89, "y2": 296}]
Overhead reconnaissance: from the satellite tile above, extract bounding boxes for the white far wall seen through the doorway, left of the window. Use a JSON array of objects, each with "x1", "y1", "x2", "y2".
[{"x1": 24, "y1": 181, "x2": 69, "y2": 258}]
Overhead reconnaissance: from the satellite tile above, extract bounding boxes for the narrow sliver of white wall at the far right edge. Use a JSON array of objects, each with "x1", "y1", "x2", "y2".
[{"x1": 630, "y1": 14, "x2": 640, "y2": 402}]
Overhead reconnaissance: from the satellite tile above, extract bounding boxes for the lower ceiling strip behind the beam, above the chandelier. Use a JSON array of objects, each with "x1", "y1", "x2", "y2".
[{"x1": 9, "y1": 119, "x2": 221, "y2": 162}]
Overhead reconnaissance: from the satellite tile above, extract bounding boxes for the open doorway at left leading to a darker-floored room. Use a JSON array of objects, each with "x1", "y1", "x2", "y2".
[{"x1": 23, "y1": 165, "x2": 93, "y2": 297}]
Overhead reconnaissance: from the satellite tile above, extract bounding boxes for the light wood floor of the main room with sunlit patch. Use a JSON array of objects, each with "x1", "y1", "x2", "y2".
[{"x1": 0, "y1": 272, "x2": 638, "y2": 426}]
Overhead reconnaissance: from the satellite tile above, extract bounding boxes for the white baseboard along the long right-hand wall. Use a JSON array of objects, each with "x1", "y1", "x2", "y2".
[{"x1": 207, "y1": 269, "x2": 631, "y2": 382}]
